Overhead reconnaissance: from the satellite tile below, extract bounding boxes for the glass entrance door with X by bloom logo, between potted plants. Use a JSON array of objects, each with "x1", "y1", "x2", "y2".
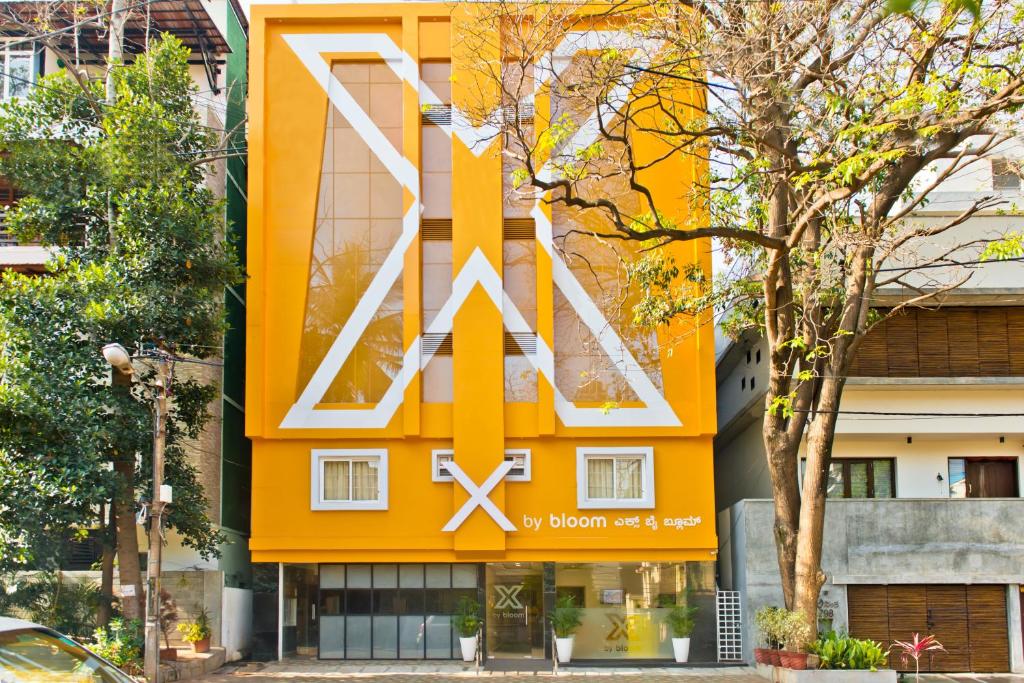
[{"x1": 486, "y1": 562, "x2": 544, "y2": 659}]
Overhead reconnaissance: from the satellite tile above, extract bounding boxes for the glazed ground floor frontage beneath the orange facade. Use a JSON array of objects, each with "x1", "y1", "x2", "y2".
[{"x1": 253, "y1": 561, "x2": 718, "y2": 670}]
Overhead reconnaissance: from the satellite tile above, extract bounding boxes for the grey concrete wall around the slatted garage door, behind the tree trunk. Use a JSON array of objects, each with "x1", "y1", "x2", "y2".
[{"x1": 719, "y1": 499, "x2": 1024, "y2": 655}]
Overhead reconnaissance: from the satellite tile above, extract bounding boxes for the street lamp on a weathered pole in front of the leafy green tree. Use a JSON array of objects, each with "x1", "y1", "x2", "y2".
[{"x1": 102, "y1": 343, "x2": 171, "y2": 683}]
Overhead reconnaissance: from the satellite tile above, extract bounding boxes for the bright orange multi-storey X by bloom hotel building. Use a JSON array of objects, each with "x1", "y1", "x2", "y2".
[{"x1": 246, "y1": 2, "x2": 728, "y2": 668}]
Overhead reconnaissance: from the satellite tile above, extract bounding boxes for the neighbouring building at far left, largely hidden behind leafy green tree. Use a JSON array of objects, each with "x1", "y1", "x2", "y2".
[{"x1": 0, "y1": 0, "x2": 252, "y2": 658}]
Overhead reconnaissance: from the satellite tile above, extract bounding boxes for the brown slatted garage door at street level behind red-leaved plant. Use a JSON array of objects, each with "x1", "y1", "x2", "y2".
[{"x1": 847, "y1": 585, "x2": 1010, "y2": 672}]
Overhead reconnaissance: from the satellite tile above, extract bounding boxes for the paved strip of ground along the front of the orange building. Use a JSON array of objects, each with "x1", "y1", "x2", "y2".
[{"x1": 195, "y1": 659, "x2": 765, "y2": 683}]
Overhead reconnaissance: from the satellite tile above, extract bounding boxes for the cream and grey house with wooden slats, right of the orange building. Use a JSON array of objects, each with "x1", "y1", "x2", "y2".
[{"x1": 715, "y1": 145, "x2": 1024, "y2": 672}]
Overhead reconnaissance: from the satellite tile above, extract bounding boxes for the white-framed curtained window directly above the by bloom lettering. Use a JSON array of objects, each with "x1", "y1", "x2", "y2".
[{"x1": 577, "y1": 446, "x2": 654, "y2": 510}]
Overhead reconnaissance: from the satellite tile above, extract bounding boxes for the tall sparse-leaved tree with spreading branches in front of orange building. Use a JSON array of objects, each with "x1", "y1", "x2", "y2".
[{"x1": 456, "y1": 0, "x2": 1024, "y2": 626}]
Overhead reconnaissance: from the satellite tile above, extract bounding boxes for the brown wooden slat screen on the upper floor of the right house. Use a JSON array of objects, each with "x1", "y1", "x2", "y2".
[{"x1": 849, "y1": 306, "x2": 1024, "y2": 377}]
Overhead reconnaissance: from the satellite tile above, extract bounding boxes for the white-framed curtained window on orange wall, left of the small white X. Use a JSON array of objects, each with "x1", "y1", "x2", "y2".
[{"x1": 310, "y1": 449, "x2": 387, "y2": 510}]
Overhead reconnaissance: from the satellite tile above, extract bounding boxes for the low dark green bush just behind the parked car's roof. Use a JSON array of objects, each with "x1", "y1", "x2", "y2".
[{"x1": 0, "y1": 571, "x2": 100, "y2": 638}]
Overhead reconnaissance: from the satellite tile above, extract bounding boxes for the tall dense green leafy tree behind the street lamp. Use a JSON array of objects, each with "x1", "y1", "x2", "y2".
[{"x1": 0, "y1": 36, "x2": 242, "y2": 617}]
